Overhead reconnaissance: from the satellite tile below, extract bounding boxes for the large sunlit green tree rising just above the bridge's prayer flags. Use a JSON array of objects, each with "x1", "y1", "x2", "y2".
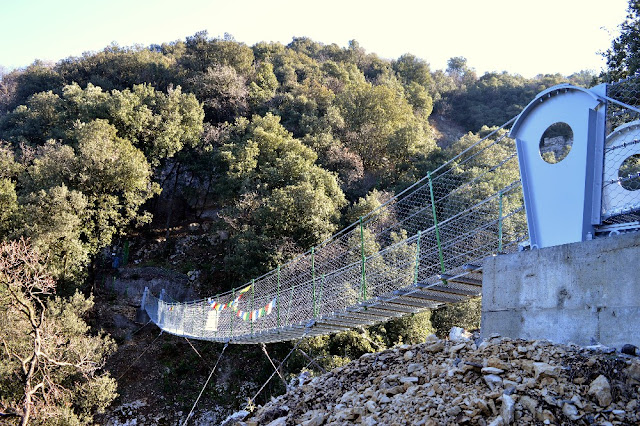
[{"x1": 219, "y1": 114, "x2": 345, "y2": 280}]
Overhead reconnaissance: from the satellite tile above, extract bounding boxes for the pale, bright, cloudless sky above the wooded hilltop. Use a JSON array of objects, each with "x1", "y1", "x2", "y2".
[{"x1": 0, "y1": 0, "x2": 628, "y2": 77}]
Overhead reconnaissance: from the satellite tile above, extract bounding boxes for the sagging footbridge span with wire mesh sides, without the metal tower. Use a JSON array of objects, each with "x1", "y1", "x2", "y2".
[{"x1": 144, "y1": 115, "x2": 527, "y2": 343}]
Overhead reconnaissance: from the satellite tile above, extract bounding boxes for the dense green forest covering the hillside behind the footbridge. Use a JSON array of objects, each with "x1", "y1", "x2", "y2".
[{"x1": 0, "y1": 0, "x2": 640, "y2": 424}]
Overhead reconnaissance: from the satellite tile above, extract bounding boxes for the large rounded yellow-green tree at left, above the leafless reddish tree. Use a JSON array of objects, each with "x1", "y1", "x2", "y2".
[{"x1": 7, "y1": 120, "x2": 158, "y2": 282}]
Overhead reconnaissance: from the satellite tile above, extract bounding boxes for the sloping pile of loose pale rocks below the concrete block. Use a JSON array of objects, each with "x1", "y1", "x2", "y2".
[{"x1": 232, "y1": 336, "x2": 640, "y2": 426}]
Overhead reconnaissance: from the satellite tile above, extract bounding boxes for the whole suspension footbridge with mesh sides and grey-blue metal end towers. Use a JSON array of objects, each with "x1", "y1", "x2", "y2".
[{"x1": 142, "y1": 80, "x2": 640, "y2": 344}]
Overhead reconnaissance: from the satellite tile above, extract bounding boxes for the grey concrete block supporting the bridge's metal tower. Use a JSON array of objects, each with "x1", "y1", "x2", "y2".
[{"x1": 481, "y1": 234, "x2": 640, "y2": 349}]
